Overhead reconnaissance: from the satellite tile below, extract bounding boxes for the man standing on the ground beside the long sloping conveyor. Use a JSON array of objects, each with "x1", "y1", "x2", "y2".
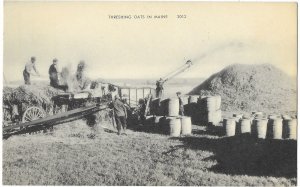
[{"x1": 109, "y1": 95, "x2": 127, "y2": 135}]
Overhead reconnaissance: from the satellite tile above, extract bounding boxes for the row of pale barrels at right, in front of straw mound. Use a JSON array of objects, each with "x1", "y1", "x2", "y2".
[{"x1": 223, "y1": 112, "x2": 297, "y2": 139}]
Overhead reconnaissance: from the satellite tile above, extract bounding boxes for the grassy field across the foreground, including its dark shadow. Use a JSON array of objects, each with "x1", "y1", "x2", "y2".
[{"x1": 3, "y1": 117, "x2": 297, "y2": 186}]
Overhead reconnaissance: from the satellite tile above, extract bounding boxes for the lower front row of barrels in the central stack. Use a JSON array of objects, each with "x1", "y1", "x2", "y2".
[{"x1": 146, "y1": 116, "x2": 192, "y2": 137}]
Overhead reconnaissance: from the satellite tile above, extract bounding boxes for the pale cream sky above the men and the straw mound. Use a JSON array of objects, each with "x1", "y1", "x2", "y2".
[{"x1": 3, "y1": 1, "x2": 297, "y2": 81}]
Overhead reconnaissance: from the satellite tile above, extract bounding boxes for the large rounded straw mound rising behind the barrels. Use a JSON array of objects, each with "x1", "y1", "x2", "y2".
[{"x1": 190, "y1": 64, "x2": 297, "y2": 112}]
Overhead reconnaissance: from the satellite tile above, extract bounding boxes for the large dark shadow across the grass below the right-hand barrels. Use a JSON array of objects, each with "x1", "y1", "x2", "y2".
[{"x1": 172, "y1": 134, "x2": 297, "y2": 178}]
